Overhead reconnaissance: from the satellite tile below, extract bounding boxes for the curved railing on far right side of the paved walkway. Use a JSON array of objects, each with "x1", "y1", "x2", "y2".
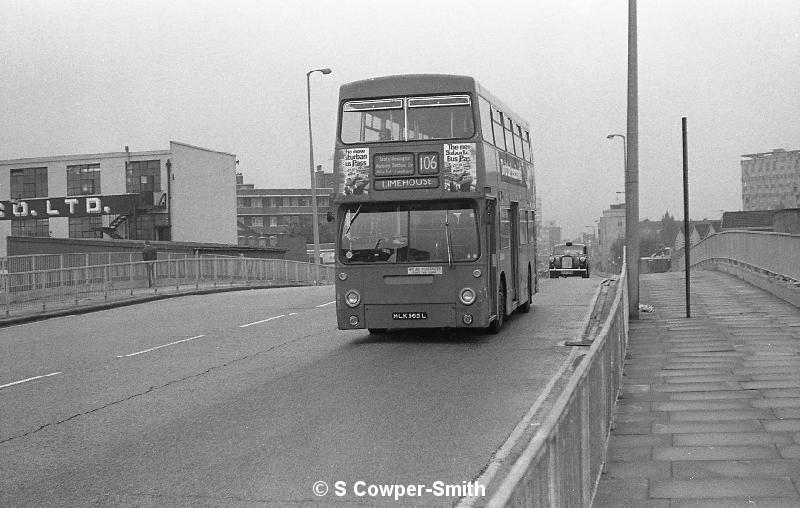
[{"x1": 672, "y1": 231, "x2": 800, "y2": 281}]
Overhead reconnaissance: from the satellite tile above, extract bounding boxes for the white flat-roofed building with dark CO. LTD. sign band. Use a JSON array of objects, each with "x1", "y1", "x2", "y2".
[{"x1": 0, "y1": 141, "x2": 237, "y2": 255}]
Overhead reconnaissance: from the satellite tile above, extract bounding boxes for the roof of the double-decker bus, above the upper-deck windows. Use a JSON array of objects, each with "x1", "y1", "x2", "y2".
[{"x1": 339, "y1": 74, "x2": 529, "y2": 130}]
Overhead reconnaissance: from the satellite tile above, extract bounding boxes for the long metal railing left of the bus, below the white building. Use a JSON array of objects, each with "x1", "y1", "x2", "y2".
[{"x1": 0, "y1": 253, "x2": 334, "y2": 315}]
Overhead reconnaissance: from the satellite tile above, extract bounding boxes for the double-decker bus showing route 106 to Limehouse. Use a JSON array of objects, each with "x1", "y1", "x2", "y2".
[{"x1": 329, "y1": 74, "x2": 538, "y2": 333}]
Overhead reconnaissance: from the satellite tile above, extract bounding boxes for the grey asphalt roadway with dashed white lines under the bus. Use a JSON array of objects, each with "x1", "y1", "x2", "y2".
[{"x1": 0, "y1": 277, "x2": 605, "y2": 506}]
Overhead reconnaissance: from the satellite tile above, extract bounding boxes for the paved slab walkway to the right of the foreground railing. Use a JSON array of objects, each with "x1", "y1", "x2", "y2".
[{"x1": 593, "y1": 271, "x2": 800, "y2": 508}]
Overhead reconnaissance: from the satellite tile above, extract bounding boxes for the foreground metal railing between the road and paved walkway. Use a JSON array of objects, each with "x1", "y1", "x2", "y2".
[{"x1": 486, "y1": 257, "x2": 628, "y2": 507}]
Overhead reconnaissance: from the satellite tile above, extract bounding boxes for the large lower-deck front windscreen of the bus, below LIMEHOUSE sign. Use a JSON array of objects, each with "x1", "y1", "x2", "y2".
[{"x1": 339, "y1": 201, "x2": 480, "y2": 264}]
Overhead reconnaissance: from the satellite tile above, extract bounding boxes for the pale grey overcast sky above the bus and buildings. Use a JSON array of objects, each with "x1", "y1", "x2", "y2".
[{"x1": 0, "y1": 0, "x2": 800, "y2": 236}]
